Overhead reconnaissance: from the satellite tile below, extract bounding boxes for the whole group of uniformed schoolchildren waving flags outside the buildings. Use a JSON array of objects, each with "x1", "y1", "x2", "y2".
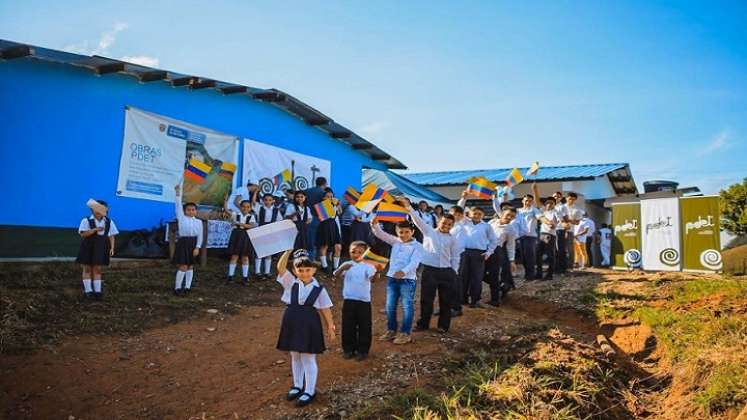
[{"x1": 78, "y1": 180, "x2": 604, "y2": 406}]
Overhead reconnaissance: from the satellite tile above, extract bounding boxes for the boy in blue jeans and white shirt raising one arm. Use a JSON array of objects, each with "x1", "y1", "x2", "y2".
[{"x1": 371, "y1": 219, "x2": 423, "y2": 344}]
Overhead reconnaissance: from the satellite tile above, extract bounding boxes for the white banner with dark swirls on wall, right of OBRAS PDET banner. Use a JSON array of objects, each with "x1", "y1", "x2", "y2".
[{"x1": 244, "y1": 139, "x2": 332, "y2": 194}]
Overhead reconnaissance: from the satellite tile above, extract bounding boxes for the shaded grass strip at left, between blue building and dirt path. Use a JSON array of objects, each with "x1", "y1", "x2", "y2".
[{"x1": 0, "y1": 258, "x2": 278, "y2": 354}]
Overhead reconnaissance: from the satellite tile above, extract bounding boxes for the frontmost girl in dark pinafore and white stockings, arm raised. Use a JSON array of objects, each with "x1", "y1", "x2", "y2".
[{"x1": 277, "y1": 250, "x2": 335, "y2": 407}]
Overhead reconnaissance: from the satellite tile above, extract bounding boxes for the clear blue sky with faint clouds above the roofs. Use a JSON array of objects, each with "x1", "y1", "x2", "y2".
[{"x1": 0, "y1": 0, "x2": 747, "y2": 193}]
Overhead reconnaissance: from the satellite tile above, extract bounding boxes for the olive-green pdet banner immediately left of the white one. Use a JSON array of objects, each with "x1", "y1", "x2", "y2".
[{"x1": 612, "y1": 203, "x2": 643, "y2": 269}]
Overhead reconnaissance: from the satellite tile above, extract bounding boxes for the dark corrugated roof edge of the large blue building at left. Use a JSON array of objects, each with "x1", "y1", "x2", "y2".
[{"x1": 0, "y1": 39, "x2": 407, "y2": 169}]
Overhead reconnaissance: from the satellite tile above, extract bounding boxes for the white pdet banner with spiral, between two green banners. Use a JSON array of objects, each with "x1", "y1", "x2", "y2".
[{"x1": 641, "y1": 197, "x2": 682, "y2": 271}]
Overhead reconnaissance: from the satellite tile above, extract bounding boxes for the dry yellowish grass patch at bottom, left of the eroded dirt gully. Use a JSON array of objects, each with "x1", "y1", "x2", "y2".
[{"x1": 367, "y1": 329, "x2": 632, "y2": 420}]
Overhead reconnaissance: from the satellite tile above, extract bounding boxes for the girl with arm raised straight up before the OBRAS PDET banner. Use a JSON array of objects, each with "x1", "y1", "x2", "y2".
[{"x1": 171, "y1": 185, "x2": 202, "y2": 295}]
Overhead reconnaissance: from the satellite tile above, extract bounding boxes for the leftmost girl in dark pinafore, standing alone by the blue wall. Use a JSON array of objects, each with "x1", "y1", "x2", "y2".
[{"x1": 75, "y1": 200, "x2": 119, "y2": 299}]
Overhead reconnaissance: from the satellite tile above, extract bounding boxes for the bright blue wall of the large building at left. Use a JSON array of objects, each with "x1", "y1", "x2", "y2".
[{"x1": 0, "y1": 58, "x2": 385, "y2": 230}]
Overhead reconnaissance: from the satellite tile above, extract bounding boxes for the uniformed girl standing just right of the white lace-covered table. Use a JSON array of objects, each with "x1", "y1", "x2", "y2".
[{"x1": 224, "y1": 195, "x2": 257, "y2": 285}]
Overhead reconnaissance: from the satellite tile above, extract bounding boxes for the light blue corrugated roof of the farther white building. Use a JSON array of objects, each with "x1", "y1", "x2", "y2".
[{"x1": 404, "y1": 163, "x2": 637, "y2": 194}]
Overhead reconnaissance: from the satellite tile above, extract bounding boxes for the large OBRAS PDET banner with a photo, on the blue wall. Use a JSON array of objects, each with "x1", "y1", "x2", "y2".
[{"x1": 117, "y1": 107, "x2": 238, "y2": 207}]
